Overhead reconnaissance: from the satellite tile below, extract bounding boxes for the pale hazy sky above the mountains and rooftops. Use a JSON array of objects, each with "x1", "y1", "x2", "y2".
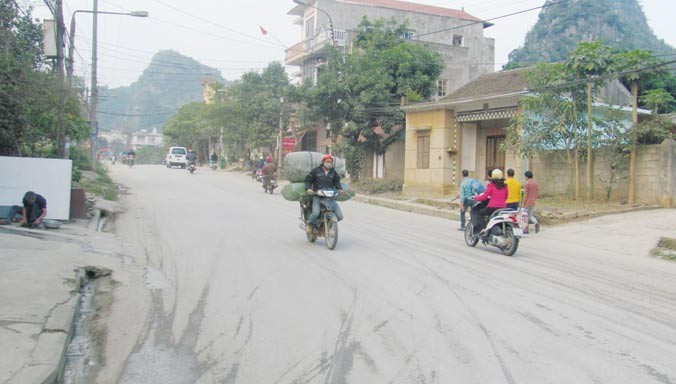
[{"x1": 18, "y1": 0, "x2": 676, "y2": 87}]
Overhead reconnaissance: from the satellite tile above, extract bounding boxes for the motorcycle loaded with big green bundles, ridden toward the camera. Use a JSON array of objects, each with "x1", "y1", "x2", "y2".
[{"x1": 300, "y1": 189, "x2": 338, "y2": 250}]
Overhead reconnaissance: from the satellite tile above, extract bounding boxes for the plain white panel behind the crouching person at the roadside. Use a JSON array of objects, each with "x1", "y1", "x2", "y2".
[{"x1": 0, "y1": 156, "x2": 72, "y2": 220}]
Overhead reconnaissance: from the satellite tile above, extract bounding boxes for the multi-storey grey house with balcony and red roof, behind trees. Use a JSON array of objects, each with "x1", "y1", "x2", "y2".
[{"x1": 284, "y1": 0, "x2": 495, "y2": 180}]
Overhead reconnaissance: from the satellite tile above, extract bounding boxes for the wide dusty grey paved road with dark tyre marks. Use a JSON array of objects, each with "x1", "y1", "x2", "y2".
[{"x1": 97, "y1": 166, "x2": 676, "y2": 384}]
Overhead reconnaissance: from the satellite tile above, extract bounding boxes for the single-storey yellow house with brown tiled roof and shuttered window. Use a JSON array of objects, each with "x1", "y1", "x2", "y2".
[{"x1": 403, "y1": 69, "x2": 527, "y2": 195}]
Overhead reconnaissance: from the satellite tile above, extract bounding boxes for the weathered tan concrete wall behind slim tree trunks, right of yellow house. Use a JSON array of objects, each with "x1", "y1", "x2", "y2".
[{"x1": 532, "y1": 140, "x2": 676, "y2": 207}]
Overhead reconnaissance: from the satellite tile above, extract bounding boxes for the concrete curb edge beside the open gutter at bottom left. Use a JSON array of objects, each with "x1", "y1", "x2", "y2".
[{"x1": 7, "y1": 268, "x2": 86, "y2": 384}]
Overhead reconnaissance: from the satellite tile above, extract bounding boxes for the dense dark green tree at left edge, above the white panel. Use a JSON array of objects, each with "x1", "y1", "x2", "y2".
[{"x1": 0, "y1": 0, "x2": 89, "y2": 157}]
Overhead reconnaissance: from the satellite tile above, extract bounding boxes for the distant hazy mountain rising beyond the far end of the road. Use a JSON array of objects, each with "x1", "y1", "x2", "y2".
[{"x1": 98, "y1": 51, "x2": 224, "y2": 132}]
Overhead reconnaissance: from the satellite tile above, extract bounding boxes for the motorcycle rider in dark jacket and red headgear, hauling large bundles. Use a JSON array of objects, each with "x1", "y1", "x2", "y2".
[{"x1": 305, "y1": 155, "x2": 343, "y2": 233}]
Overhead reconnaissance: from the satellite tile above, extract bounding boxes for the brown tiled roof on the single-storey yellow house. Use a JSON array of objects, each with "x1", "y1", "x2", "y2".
[{"x1": 439, "y1": 68, "x2": 529, "y2": 102}]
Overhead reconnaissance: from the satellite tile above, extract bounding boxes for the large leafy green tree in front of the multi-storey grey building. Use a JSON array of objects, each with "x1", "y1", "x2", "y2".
[{"x1": 308, "y1": 18, "x2": 443, "y2": 180}]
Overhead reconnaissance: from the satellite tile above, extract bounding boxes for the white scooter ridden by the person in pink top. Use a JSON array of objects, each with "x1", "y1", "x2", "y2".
[{"x1": 465, "y1": 200, "x2": 523, "y2": 256}]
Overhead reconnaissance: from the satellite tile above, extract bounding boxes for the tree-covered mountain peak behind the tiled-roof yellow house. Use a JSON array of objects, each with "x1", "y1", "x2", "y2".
[{"x1": 508, "y1": 0, "x2": 676, "y2": 67}]
